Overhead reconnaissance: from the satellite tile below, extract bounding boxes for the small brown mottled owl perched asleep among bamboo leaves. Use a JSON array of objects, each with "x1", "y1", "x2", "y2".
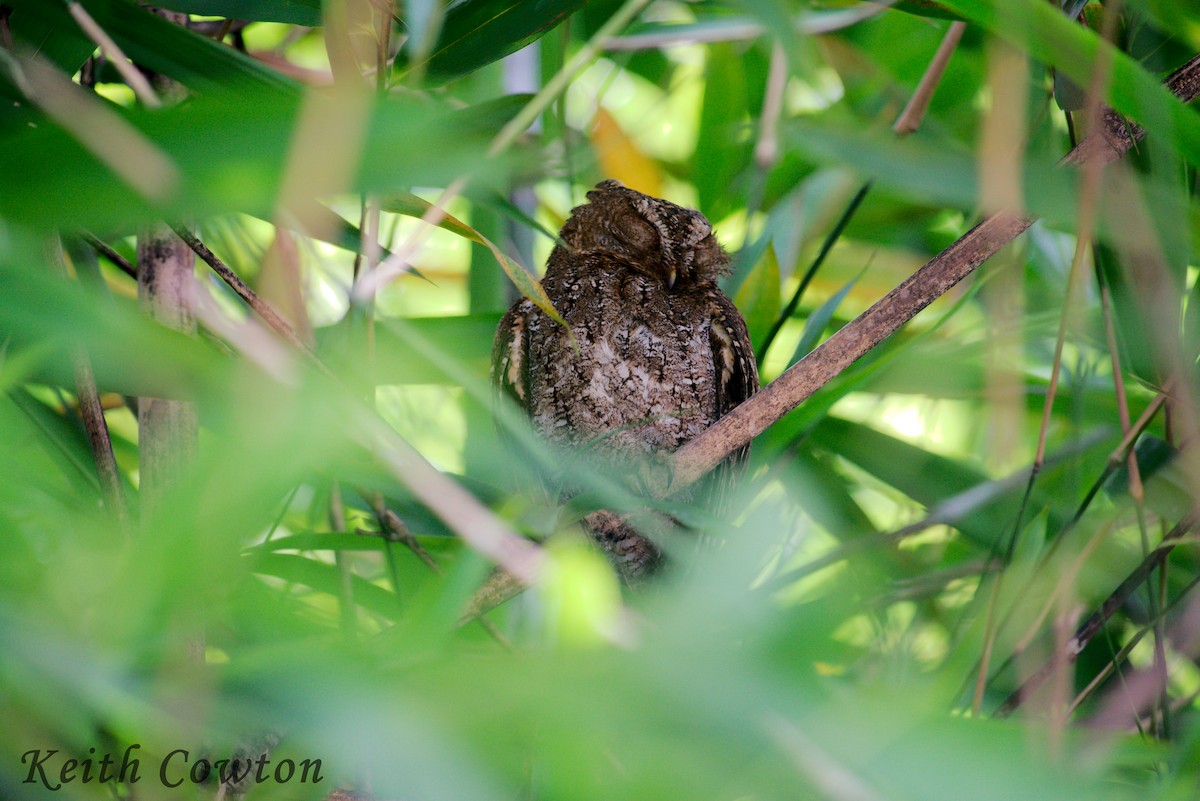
[{"x1": 492, "y1": 180, "x2": 758, "y2": 583}]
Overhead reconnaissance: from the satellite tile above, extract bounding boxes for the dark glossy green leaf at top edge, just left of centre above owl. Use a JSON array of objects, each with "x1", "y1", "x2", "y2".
[{"x1": 426, "y1": 0, "x2": 583, "y2": 79}]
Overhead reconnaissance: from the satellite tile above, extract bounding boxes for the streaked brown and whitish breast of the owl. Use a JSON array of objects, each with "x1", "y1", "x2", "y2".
[{"x1": 529, "y1": 271, "x2": 716, "y2": 454}]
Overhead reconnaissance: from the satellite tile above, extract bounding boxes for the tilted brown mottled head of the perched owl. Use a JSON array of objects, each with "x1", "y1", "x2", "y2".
[{"x1": 562, "y1": 180, "x2": 730, "y2": 289}]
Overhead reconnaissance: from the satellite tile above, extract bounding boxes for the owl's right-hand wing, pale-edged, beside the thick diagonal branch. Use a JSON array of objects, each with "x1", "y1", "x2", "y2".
[{"x1": 708, "y1": 291, "x2": 758, "y2": 512}]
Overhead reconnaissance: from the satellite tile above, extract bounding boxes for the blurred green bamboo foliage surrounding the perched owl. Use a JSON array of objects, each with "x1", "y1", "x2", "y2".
[{"x1": 0, "y1": 0, "x2": 1200, "y2": 801}]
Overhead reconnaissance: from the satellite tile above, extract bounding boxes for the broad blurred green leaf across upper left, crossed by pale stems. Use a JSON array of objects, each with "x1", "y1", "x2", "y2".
[{"x1": 0, "y1": 91, "x2": 523, "y2": 235}]
